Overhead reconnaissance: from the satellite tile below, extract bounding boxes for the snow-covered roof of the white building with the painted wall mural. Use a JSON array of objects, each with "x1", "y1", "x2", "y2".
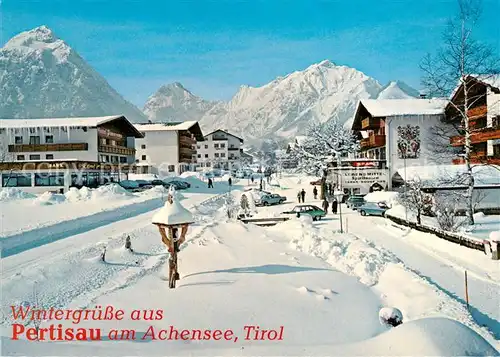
[{"x1": 351, "y1": 98, "x2": 448, "y2": 131}]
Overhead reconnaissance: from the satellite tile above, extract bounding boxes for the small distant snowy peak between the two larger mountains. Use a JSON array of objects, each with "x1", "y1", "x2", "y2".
[{"x1": 143, "y1": 82, "x2": 216, "y2": 121}]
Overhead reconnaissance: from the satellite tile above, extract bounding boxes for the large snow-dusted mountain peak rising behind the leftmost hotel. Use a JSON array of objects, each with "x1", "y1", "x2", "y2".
[{"x1": 0, "y1": 26, "x2": 147, "y2": 122}]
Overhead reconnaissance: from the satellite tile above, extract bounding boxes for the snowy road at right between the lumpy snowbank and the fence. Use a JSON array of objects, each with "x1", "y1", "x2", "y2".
[{"x1": 345, "y1": 209, "x2": 500, "y2": 340}]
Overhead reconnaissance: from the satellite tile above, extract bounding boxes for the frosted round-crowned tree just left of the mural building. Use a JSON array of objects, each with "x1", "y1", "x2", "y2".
[{"x1": 291, "y1": 117, "x2": 359, "y2": 200}]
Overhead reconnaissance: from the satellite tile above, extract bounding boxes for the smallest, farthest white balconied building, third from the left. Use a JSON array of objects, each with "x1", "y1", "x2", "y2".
[{"x1": 196, "y1": 129, "x2": 243, "y2": 170}]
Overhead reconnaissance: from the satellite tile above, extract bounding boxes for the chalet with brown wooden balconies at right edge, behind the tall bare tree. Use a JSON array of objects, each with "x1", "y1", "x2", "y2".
[{"x1": 446, "y1": 75, "x2": 500, "y2": 165}]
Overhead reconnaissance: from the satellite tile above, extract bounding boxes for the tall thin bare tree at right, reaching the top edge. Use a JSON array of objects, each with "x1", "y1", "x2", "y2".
[{"x1": 420, "y1": 0, "x2": 499, "y2": 225}]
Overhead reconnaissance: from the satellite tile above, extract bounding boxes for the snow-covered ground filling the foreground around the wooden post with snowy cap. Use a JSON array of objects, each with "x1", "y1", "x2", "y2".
[{"x1": 1, "y1": 173, "x2": 500, "y2": 356}]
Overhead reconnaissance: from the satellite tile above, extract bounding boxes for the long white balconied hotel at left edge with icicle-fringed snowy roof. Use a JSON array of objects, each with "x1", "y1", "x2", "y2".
[{"x1": 0, "y1": 115, "x2": 142, "y2": 192}]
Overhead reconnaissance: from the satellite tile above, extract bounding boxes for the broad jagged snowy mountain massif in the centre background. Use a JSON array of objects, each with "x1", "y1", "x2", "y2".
[{"x1": 192, "y1": 61, "x2": 382, "y2": 141}]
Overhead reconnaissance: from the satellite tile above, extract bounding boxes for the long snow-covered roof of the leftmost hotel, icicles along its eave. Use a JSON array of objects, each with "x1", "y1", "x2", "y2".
[{"x1": 0, "y1": 115, "x2": 143, "y2": 138}]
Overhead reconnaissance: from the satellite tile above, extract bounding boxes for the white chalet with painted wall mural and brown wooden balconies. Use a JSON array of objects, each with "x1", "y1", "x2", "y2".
[{"x1": 352, "y1": 98, "x2": 448, "y2": 189}]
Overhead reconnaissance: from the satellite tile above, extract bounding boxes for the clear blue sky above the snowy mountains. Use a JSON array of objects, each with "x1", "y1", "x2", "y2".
[{"x1": 0, "y1": 0, "x2": 500, "y2": 107}]
